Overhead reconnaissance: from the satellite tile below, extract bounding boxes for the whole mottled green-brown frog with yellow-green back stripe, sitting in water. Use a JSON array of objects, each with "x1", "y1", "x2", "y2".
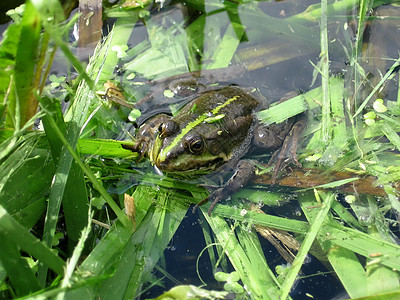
[{"x1": 128, "y1": 86, "x2": 304, "y2": 214}]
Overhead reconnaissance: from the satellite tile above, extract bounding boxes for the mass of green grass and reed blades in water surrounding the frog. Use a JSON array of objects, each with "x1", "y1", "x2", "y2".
[{"x1": 0, "y1": 0, "x2": 400, "y2": 299}]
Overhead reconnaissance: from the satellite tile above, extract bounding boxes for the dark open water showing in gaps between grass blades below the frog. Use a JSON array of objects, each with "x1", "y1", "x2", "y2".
[{"x1": 141, "y1": 210, "x2": 347, "y2": 300}]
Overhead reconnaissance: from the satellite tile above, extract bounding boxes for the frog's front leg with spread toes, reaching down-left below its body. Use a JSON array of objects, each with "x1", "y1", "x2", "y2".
[{"x1": 193, "y1": 160, "x2": 255, "y2": 216}]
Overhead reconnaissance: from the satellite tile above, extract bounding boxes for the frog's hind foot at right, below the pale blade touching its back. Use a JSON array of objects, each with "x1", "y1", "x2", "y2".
[{"x1": 268, "y1": 118, "x2": 306, "y2": 184}]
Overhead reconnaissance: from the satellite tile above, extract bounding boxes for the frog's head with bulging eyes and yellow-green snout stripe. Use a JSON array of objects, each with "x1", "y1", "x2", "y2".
[{"x1": 150, "y1": 118, "x2": 228, "y2": 177}]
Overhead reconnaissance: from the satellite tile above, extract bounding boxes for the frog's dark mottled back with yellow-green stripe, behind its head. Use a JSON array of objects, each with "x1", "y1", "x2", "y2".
[{"x1": 173, "y1": 86, "x2": 259, "y2": 163}]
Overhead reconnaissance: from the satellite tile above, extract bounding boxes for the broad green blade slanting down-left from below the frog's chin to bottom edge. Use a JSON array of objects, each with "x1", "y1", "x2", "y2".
[{"x1": 94, "y1": 185, "x2": 187, "y2": 299}]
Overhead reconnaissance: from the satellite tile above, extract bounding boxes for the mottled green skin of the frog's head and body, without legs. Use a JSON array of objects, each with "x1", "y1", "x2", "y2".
[{"x1": 149, "y1": 87, "x2": 259, "y2": 175}]
